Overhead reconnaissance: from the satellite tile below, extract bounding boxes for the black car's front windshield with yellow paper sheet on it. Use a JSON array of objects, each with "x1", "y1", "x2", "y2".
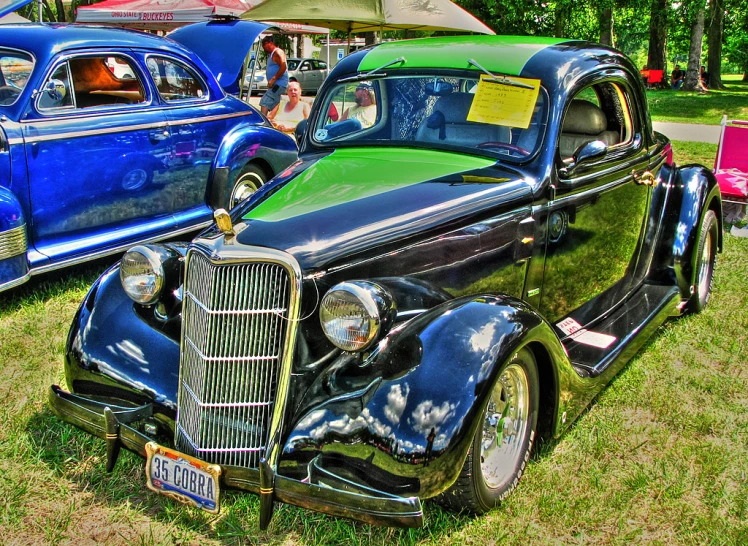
[{"x1": 311, "y1": 72, "x2": 548, "y2": 161}]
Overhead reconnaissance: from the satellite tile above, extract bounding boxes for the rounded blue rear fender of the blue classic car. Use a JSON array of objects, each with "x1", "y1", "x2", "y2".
[{"x1": 207, "y1": 124, "x2": 298, "y2": 208}]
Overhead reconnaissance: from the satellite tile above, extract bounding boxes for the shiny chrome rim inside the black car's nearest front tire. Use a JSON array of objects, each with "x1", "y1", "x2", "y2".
[{"x1": 480, "y1": 364, "x2": 530, "y2": 489}]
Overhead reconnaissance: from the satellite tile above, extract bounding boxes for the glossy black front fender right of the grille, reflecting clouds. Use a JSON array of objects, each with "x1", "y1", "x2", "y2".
[{"x1": 280, "y1": 296, "x2": 560, "y2": 498}]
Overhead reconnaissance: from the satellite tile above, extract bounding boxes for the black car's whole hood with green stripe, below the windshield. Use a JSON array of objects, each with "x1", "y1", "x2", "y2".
[{"x1": 236, "y1": 148, "x2": 532, "y2": 270}]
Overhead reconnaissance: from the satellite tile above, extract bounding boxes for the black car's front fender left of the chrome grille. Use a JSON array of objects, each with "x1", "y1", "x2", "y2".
[{"x1": 65, "y1": 263, "x2": 179, "y2": 417}]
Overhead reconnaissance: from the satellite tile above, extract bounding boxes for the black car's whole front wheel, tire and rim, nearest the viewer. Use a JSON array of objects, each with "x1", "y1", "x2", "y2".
[{"x1": 434, "y1": 349, "x2": 539, "y2": 514}]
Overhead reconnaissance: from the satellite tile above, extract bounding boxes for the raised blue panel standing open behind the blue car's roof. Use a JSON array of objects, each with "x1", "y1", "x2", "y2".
[{"x1": 169, "y1": 21, "x2": 270, "y2": 94}]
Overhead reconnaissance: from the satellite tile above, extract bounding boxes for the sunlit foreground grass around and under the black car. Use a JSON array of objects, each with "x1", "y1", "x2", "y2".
[{"x1": 0, "y1": 233, "x2": 748, "y2": 546}]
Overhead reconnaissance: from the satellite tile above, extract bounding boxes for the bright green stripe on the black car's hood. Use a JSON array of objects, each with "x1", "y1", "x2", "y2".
[{"x1": 244, "y1": 148, "x2": 496, "y2": 222}]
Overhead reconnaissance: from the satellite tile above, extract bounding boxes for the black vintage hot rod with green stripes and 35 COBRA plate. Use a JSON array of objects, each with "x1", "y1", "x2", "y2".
[{"x1": 50, "y1": 36, "x2": 722, "y2": 528}]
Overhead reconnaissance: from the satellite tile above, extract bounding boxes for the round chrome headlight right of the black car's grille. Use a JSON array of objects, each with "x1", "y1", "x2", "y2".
[{"x1": 319, "y1": 281, "x2": 395, "y2": 352}]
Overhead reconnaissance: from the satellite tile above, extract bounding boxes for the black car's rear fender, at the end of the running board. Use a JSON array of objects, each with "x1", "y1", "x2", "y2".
[{"x1": 654, "y1": 165, "x2": 723, "y2": 300}]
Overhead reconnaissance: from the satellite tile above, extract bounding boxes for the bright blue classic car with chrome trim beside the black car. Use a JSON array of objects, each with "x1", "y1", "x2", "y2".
[{"x1": 0, "y1": 21, "x2": 297, "y2": 291}]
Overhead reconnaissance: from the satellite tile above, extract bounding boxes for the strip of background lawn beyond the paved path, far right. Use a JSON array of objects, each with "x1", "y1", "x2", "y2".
[{"x1": 647, "y1": 75, "x2": 748, "y2": 125}]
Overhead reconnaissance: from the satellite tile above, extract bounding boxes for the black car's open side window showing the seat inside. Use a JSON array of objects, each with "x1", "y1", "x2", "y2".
[{"x1": 558, "y1": 82, "x2": 634, "y2": 160}]
